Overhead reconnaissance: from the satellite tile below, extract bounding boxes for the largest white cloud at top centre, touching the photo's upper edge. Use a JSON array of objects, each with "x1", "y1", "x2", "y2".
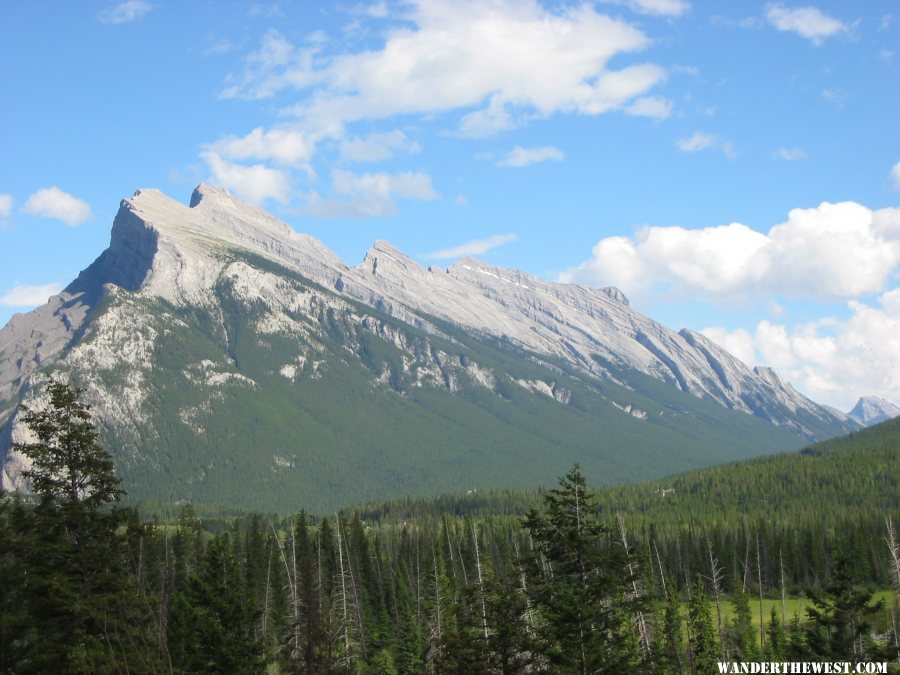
[{"x1": 229, "y1": 0, "x2": 666, "y2": 134}]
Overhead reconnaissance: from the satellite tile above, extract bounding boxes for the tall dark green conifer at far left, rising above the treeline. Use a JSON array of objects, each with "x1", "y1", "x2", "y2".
[{"x1": 13, "y1": 381, "x2": 161, "y2": 673}]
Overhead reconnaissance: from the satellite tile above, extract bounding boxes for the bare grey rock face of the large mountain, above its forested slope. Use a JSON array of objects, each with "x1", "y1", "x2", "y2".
[{"x1": 0, "y1": 185, "x2": 856, "y2": 508}]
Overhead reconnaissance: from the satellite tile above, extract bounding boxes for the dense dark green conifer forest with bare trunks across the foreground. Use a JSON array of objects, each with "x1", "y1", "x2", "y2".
[{"x1": 0, "y1": 383, "x2": 900, "y2": 674}]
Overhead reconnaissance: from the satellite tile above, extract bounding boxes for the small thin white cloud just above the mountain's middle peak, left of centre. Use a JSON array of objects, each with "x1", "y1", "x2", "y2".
[{"x1": 304, "y1": 169, "x2": 441, "y2": 218}]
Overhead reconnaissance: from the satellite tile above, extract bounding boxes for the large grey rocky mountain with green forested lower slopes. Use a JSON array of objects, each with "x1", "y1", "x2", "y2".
[{"x1": 0, "y1": 185, "x2": 858, "y2": 509}]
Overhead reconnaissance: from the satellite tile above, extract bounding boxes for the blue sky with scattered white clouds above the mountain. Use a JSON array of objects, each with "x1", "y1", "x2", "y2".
[{"x1": 0, "y1": 0, "x2": 900, "y2": 409}]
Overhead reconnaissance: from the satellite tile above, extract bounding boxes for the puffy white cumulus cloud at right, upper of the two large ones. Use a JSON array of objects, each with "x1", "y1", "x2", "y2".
[{"x1": 560, "y1": 202, "x2": 900, "y2": 301}]
